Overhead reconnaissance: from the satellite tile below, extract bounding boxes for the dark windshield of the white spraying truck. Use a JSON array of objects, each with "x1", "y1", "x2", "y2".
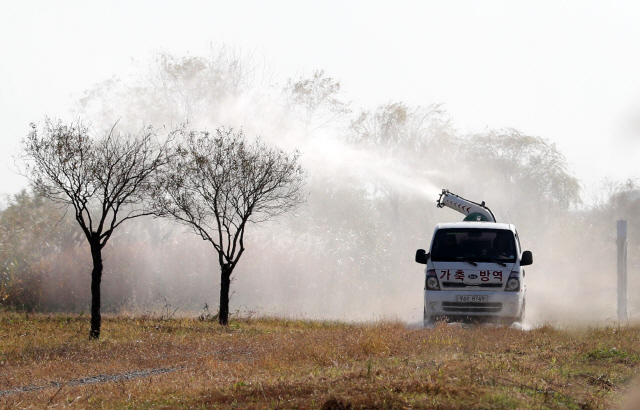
[{"x1": 431, "y1": 228, "x2": 516, "y2": 263}]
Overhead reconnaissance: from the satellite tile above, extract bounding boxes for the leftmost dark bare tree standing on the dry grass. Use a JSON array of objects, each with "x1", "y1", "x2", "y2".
[{"x1": 22, "y1": 119, "x2": 171, "y2": 339}]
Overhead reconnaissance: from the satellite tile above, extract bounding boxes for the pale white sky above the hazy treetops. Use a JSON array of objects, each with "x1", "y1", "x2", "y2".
[{"x1": 0, "y1": 0, "x2": 640, "y2": 199}]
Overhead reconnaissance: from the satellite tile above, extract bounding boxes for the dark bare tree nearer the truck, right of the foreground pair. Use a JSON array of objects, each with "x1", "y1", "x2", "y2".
[{"x1": 154, "y1": 128, "x2": 306, "y2": 325}]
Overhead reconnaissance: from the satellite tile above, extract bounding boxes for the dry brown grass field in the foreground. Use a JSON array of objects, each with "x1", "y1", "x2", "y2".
[{"x1": 0, "y1": 312, "x2": 640, "y2": 409}]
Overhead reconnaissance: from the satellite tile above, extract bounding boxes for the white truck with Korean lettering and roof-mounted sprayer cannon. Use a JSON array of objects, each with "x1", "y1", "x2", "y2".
[{"x1": 416, "y1": 189, "x2": 533, "y2": 323}]
